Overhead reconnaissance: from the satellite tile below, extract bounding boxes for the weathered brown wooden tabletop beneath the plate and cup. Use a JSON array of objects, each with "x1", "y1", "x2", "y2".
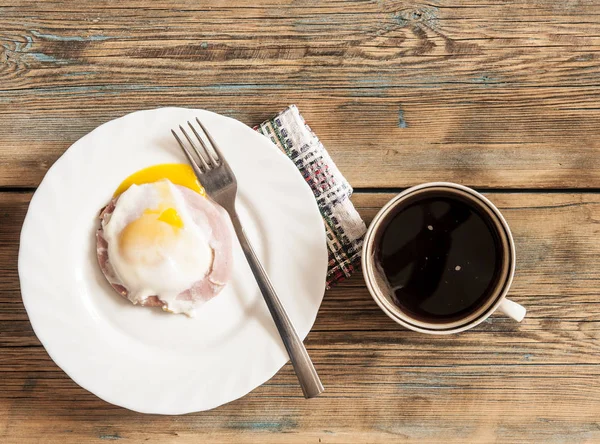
[{"x1": 0, "y1": 0, "x2": 600, "y2": 444}]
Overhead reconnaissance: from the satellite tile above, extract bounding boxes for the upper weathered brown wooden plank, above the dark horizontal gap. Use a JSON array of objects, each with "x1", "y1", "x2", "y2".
[{"x1": 0, "y1": 0, "x2": 600, "y2": 188}]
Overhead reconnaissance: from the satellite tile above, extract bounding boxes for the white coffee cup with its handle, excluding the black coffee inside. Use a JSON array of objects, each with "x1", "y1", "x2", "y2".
[{"x1": 362, "y1": 182, "x2": 526, "y2": 334}]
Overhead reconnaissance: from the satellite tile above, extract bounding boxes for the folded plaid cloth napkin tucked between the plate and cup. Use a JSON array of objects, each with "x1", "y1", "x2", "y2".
[{"x1": 254, "y1": 105, "x2": 367, "y2": 288}]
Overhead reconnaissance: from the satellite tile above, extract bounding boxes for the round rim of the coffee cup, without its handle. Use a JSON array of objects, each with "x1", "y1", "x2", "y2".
[{"x1": 361, "y1": 182, "x2": 516, "y2": 335}]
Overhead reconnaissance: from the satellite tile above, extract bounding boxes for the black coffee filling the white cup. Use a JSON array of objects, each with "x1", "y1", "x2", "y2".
[{"x1": 377, "y1": 192, "x2": 504, "y2": 323}]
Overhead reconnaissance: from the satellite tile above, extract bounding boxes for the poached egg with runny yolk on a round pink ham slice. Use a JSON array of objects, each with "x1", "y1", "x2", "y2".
[{"x1": 97, "y1": 164, "x2": 231, "y2": 316}]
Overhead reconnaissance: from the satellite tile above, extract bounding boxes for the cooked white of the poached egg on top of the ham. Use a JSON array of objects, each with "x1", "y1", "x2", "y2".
[{"x1": 104, "y1": 180, "x2": 214, "y2": 314}]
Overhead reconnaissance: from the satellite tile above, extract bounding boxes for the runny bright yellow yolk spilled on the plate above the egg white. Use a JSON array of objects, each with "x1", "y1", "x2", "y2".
[{"x1": 113, "y1": 163, "x2": 206, "y2": 197}]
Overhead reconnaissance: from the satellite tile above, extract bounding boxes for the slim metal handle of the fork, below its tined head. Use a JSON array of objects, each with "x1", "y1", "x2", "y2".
[{"x1": 229, "y1": 211, "x2": 324, "y2": 398}]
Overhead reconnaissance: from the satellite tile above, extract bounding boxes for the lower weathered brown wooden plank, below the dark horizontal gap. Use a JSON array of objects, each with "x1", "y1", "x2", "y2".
[{"x1": 0, "y1": 192, "x2": 600, "y2": 443}]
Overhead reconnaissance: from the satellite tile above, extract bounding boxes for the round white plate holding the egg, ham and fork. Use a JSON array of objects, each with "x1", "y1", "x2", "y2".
[{"x1": 19, "y1": 108, "x2": 327, "y2": 414}]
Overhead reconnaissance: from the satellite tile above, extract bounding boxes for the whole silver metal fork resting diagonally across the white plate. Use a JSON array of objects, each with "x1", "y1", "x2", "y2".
[{"x1": 171, "y1": 118, "x2": 324, "y2": 398}]
